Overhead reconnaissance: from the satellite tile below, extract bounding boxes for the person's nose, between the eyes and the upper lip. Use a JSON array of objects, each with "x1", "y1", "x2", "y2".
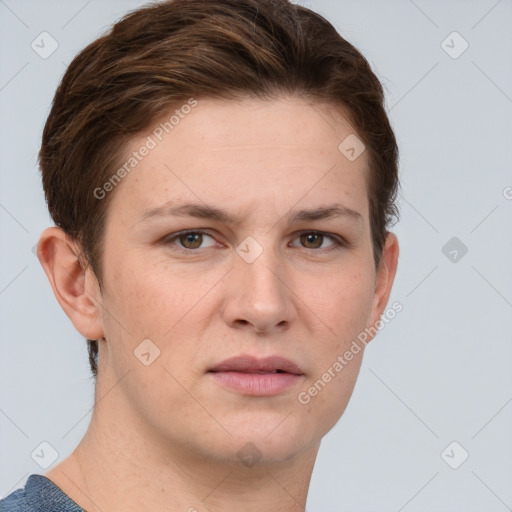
[{"x1": 223, "y1": 242, "x2": 297, "y2": 334}]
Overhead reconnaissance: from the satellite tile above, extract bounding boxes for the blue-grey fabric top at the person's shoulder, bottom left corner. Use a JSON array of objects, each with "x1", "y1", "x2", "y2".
[{"x1": 0, "y1": 475, "x2": 85, "y2": 512}]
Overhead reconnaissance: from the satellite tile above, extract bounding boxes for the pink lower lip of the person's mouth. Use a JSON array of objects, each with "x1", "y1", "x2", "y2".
[{"x1": 210, "y1": 372, "x2": 302, "y2": 396}]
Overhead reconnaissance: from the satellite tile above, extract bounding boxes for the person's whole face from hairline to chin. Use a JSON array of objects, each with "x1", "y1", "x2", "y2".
[{"x1": 89, "y1": 98, "x2": 392, "y2": 461}]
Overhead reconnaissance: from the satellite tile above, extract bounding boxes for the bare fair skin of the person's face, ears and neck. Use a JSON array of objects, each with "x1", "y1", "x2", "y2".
[{"x1": 38, "y1": 97, "x2": 398, "y2": 512}]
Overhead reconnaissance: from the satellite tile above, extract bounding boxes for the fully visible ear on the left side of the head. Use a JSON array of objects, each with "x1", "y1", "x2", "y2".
[{"x1": 37, "y1": 227, "x2": 104, "y2": 340}]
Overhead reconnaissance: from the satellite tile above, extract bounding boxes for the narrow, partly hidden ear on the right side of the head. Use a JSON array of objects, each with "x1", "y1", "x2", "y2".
[{"x1": 371, "y1": 233, "x2": 399, "y2": 332}]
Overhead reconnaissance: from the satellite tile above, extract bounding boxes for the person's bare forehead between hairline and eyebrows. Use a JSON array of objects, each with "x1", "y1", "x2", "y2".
[{"x1": 107, "y1": 98, "x2": 368, "y2": 224}]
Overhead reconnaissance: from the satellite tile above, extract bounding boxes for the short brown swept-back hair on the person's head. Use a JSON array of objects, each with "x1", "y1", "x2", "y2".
[{"x1": 39, "y1": 0, "x2": 398, "y2": 377}]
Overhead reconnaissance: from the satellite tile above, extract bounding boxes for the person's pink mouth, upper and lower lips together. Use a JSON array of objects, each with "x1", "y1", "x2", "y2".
[{"x1": 208, "y1": 355, "x2": 304, "y2": 396}]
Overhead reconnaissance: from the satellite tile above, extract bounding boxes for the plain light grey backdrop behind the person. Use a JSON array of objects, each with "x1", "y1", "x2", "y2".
[{"x1": 0, "y1": 0, "x2": 512, "y2": 512}]
